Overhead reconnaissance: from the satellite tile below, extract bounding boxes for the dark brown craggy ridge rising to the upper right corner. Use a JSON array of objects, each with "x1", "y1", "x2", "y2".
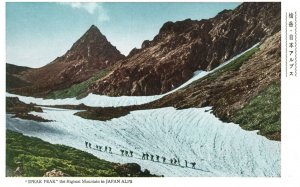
[{"x1": 89, "y1": 3, "x2": 281, "y2": 96}]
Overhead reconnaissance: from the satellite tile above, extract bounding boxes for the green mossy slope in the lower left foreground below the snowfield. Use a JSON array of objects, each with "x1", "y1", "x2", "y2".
[{"x1": 6, "y1": 130, "x2": 157, "y2": 177}]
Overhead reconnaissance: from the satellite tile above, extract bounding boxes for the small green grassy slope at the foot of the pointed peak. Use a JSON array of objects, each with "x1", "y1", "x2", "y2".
[{"x1": 46, "y1": 68, "x2": 111, "y2": 99}]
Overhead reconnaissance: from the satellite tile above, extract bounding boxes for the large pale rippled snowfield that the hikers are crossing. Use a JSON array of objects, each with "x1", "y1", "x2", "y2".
[{"x1": 7, "y1": 107, "x2": 280, "y2": 177}]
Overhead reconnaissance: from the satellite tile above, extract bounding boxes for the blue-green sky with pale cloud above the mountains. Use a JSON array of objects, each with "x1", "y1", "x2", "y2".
[{"x1": 6, "y1": 2, "x2": 240, "y2": 67}]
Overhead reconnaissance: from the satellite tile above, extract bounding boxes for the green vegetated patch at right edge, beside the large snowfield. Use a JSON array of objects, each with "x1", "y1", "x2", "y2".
[{"x1": 232, "y1": 82, "x2": 281, "y2": 140}]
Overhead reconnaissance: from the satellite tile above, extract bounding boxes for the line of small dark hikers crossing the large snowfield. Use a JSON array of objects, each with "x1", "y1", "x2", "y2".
[{"x1": 85, "y1": 141, "x2": 196, "y2": 169}]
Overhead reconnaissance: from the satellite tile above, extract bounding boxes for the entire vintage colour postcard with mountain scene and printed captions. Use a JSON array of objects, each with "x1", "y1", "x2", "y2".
[{"x1": 2, "y1": 2, "x2": 297, "y2": 186}]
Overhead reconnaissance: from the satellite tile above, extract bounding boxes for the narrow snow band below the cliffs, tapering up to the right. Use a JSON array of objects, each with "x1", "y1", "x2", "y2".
[{"x1": 6, "y1": 43, "x2": 259, "y2": 107}]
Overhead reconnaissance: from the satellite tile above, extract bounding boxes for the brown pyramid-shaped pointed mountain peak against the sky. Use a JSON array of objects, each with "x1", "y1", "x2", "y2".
[{"x1": 13, "y1": 25, "x2": 124, "y2": 95}]
